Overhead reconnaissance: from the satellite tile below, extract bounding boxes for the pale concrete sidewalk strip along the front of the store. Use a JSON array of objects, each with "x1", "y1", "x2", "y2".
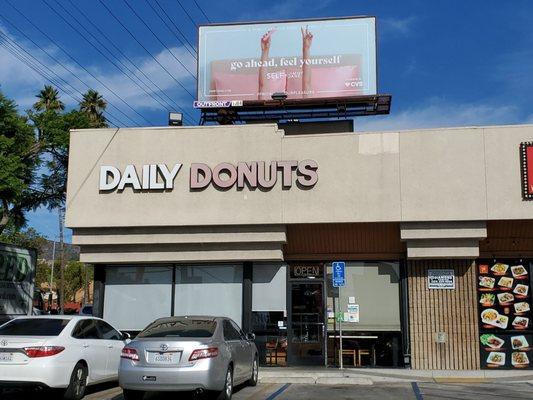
[{"x1": 259, "y1": 367, "x2": 533, "y2": 385}]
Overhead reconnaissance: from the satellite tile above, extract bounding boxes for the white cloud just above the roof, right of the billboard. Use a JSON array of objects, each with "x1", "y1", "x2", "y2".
[{"x1": 355, "y1": 99, "x2": 524, "y2": 131}]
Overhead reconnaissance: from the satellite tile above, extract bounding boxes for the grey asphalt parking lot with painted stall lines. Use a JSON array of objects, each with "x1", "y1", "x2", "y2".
[{"x1": 2, "y1": 383, "x2": 533, "y2": 400}]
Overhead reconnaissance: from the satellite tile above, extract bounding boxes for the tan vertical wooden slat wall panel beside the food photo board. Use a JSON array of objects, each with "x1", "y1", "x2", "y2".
[{"x1": 407, "y1": 260, "x2": 479, "y2": 370}]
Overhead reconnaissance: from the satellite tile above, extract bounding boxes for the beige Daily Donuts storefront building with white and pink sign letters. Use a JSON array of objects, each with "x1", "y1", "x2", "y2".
[{"x1": 67, "y1": 124, "x2": 533, "y2": 369}]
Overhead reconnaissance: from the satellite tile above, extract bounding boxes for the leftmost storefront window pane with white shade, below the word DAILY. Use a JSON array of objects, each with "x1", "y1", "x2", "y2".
[{"x1": 104, "y1": 265, "x2": 172, "y2": 331}]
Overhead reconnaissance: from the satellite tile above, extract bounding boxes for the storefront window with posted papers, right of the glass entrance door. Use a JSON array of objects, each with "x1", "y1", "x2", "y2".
[{"x1": 326, "y1": 262, "x2": 401, "y2": 366}]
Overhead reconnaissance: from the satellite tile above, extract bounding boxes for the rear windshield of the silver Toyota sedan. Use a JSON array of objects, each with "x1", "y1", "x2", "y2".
[{"x1": 137, "y1": 318, "x2": 217, "y2": 338}]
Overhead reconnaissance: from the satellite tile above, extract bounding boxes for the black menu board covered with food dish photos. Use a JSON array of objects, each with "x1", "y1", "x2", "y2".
[{"x1": 477, "y1": 260, "x2": 533, "y2": 369}]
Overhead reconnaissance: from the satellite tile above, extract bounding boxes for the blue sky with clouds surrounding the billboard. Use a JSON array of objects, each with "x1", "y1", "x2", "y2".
[{"x1": 0, "y1": 0, "x2": 533, "y2": 238}]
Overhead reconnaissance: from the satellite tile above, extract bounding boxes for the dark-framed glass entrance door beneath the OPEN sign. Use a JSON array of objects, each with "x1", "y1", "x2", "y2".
[{"x1": 289, "y1": 281, "x2": 325, "y2": 365}]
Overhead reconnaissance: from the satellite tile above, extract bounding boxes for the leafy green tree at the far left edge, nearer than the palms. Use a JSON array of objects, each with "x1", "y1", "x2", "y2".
[{"x1": 0, "y1": 92, "x2": 42, "y2": 234}]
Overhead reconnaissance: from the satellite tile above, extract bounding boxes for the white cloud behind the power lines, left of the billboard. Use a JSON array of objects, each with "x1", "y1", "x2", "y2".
[{"x1": 0, "y1": 26, "x2": 196, "y2": 120}]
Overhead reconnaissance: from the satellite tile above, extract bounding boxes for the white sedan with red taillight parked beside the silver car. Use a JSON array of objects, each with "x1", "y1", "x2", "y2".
[{"x1": 0, "y1": 315, "x2": 129, "y2": 400}]
